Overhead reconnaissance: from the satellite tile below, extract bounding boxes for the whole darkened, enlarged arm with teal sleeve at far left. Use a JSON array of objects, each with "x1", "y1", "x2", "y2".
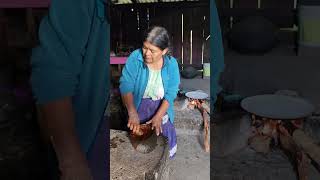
[{"x1": 31, "y1": 0, "x2": 96, "y2": 180}]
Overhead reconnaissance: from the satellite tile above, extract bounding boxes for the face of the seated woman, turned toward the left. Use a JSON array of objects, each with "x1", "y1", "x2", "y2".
[{"x1": 142, "y1": 41, "x2": 168, "y2": 64}]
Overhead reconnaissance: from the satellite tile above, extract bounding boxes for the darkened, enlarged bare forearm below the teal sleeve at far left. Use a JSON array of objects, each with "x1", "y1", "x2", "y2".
[{"x1": 38, "y1": 97, "x2": 92, "y2": 180}]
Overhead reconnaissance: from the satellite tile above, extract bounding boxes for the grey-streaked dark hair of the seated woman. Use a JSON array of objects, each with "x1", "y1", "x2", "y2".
[{"x1": 143, "y1": 26, "x2": 170, "y2": 51}]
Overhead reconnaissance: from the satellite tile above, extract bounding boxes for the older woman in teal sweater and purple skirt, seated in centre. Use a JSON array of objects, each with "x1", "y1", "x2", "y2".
[{"x1": 120, "y1": 26, "x2": 180, "y2": 158}]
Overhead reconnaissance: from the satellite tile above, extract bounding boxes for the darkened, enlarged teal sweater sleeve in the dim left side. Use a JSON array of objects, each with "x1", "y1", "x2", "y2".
[{"x1": 31, "y1": 0, "x2": 95, "y2": 104}]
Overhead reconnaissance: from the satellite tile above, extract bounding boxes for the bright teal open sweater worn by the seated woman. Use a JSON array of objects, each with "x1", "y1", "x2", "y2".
[{"x1": 120, "y1": 49, "x2": 180, "y2": 123}]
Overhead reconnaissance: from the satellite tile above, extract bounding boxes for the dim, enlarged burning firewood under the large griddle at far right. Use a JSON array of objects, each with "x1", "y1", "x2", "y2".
[{"x1": 248, "y1": 115, "x2": 320, "y2": 180}]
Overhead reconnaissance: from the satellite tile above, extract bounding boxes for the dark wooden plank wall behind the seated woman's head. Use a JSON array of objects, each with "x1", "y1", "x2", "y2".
[{"x1": 111, "y1": 1, "x2": 210, "y2": 68}]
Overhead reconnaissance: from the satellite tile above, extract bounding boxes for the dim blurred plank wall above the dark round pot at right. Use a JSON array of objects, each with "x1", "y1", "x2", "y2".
[{"x1": 216, "y1": 0, "x2": 297, "y2": 44}]
